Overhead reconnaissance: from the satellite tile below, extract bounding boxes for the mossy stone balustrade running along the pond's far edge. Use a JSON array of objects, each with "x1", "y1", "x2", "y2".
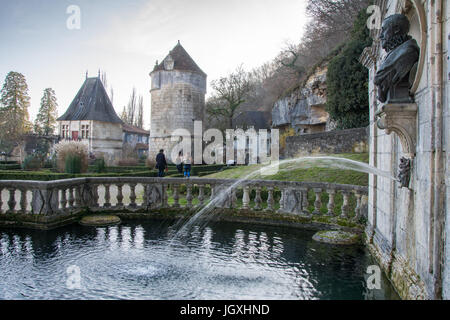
[{"x1": 0, "y1": 177, "x2": 367, "y2": 219}]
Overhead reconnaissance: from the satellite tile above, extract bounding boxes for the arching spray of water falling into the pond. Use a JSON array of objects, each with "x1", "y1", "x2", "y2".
[{"x1": 167, "y1": 156, "x2": 397, "y2": 242}]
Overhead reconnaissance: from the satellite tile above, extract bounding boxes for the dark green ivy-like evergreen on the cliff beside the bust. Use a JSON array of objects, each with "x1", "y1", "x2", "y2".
[{"x1": 327, "y1": 11, "x2": 372, "y2": 129}]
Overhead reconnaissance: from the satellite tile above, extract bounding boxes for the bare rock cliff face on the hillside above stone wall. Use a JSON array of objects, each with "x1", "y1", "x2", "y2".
[{"x1": 272, "y1": 63, "x2": 333, "y2": 134}]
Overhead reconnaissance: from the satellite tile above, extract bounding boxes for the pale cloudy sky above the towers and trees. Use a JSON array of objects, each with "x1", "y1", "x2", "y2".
[{"x1": 0, "y1": 0, "x2": 307, "y2": 128}]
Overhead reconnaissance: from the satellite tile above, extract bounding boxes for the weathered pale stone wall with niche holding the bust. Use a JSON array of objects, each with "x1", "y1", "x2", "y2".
[{"x1": 361, "y1": 0, "x2": 450, "y2": 299}]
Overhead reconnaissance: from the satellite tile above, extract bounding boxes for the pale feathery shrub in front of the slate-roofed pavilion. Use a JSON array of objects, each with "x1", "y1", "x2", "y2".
[{"x1": 55, "y1": 141, "x2": 88, "y2": 173}]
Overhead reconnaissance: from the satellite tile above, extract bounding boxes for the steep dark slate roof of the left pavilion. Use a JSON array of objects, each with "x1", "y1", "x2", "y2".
[{"x1": 58, "y1": 77, "x2": 122, "y2": 123}]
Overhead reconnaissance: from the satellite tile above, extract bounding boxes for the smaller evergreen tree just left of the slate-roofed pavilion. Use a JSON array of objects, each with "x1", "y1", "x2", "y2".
[{"x1": 34, "y1": 88, "x2": 58, "y2": 136}]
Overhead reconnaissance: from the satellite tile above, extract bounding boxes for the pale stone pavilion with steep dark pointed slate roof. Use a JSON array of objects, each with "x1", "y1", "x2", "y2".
[{"x1": 57, "y1": 77, "x2": 123, "y2": 165}]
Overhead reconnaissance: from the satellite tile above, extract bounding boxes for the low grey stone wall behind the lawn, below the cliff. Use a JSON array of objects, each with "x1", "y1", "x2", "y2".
[{"x1": 285, "y1": 128, "x2": 369, "y2": 158}]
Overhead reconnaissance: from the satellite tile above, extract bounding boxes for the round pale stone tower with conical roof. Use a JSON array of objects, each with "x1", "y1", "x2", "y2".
[{"x1": 149, "y1": 41, "x2": 207, "y2": 160}]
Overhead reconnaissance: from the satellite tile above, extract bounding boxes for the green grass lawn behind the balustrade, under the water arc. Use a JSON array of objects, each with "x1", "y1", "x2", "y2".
[{"x1": 205, "y1": 153, "x2": 369, "y2": 186}]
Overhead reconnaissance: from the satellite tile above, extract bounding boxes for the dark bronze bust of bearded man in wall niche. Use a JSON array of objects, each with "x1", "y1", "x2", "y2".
[{"x1": 374, "y1": 14, "x2": 420, "y2": 103}]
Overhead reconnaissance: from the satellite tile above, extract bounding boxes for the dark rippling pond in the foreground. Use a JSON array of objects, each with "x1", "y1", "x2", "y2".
[{"x1": 0, "y1": 220, "x2": 398, "y2": 300}]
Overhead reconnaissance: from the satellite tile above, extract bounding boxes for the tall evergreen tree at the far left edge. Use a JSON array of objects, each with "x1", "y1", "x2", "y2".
[{"x1": 0, "y1": 71, "x2": 32, "y2": 153}]
